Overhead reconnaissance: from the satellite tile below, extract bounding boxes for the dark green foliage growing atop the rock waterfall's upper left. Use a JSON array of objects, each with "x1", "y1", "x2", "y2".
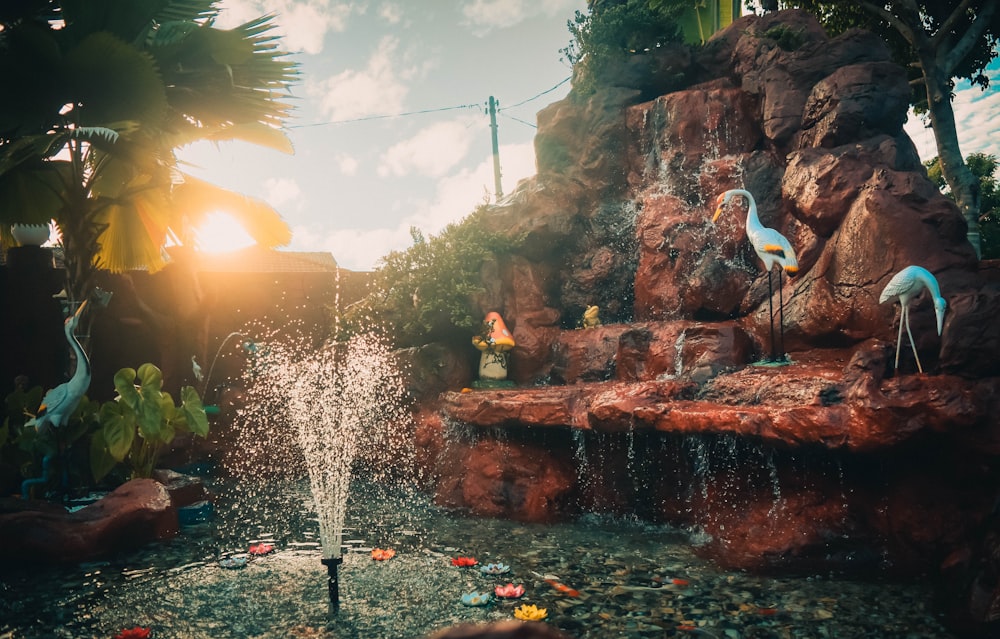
[{"x1": 560, "y1": 0, "x2": 689, "y2": 96}]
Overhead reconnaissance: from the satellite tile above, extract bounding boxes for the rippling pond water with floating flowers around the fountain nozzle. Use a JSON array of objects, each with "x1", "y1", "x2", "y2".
[{"x1": 0, "y1": 480, "x2": 952, "y2": 639}]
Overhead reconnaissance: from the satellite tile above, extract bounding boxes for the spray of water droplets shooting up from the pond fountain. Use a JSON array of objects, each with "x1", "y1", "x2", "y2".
[{"x1": 225, "y1": 333, "x2": 412, "y2": 559}]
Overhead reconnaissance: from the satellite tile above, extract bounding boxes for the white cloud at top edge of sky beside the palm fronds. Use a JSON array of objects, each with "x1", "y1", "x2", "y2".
[{"x1": 216, "y1": 0, "x2": 354, "y2": 54}]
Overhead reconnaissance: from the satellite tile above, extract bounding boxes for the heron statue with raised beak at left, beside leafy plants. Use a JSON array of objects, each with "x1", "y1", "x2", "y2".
[{"x1": 21, "y1": 300, "x2": 90, "y2": 499}]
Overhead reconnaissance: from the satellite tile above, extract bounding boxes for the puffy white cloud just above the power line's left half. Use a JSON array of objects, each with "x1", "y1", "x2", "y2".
[{"x1": 307, "y1": 36, "x2": 410, "y2": 121}]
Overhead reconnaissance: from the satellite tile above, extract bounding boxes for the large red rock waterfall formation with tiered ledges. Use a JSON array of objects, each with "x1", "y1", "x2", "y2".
[{"x1": 408, "y1": 16, "x2": 1000, "y2": 636}]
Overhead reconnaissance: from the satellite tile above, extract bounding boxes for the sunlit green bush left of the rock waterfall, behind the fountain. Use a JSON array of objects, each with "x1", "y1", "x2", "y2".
[{"x1": 340, "y1": 206, "x2": 520, "y2": 346}]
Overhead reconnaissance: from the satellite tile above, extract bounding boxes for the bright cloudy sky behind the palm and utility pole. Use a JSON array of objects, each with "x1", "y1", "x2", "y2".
[{"x1": 178, "y1": 0, "x2": 1000, "y2": 271}]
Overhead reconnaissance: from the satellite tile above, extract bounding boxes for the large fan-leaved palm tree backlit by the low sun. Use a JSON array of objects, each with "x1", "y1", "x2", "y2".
[{"x1": 0, "y1": 0, "x2": 298, "y2": 301}]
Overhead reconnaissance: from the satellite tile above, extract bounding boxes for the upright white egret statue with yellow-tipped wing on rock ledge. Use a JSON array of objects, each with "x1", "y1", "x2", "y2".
[{"x1": 712, "y1": 189, "x2": 799, "y2": 361}]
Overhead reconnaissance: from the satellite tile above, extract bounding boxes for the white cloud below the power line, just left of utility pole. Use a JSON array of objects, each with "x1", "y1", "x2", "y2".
[{"x1": 378, "y1": 116, "x2": 481, "y2": 177}]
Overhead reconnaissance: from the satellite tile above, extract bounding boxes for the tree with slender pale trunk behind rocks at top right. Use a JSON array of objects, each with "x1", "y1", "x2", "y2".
[{"x1": 782, "y1": 0, "x2": 1000, "y2": 255}]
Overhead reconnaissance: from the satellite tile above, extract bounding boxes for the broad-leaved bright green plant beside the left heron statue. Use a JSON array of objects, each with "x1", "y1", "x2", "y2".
[{"x1": 90, "y1": 364, "x2": 208, "y2": 481}]
